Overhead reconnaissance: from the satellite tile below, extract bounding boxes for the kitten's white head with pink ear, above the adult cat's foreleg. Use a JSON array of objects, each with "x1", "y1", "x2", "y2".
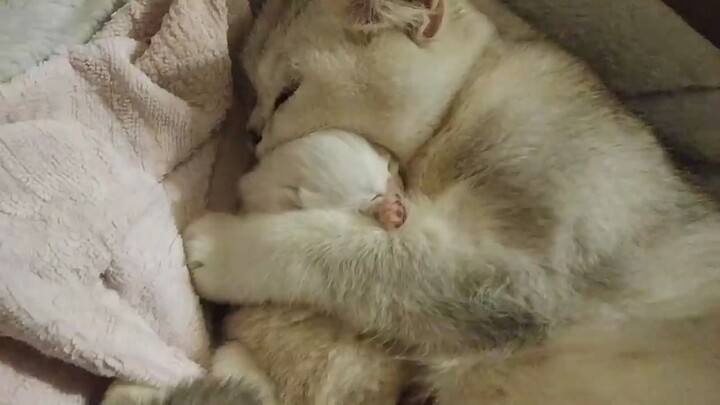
[{"x1": 239, "y1": 130, "x2": 406, "y2": 229}]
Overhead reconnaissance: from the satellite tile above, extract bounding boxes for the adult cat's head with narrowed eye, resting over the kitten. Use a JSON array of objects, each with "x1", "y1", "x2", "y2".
[{"x1": 243, "y1": 0, "x2": 492, "y2": 160}]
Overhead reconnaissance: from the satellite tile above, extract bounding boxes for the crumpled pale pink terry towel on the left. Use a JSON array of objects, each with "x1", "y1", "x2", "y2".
[{"x1": 0, "y1": 0, "x2": 247, "y2": 404}]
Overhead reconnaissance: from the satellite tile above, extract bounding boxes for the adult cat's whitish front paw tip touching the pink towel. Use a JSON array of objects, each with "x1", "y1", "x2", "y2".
[{"x1": 183, "y1": 213, "x2": 234, "y2": 300}]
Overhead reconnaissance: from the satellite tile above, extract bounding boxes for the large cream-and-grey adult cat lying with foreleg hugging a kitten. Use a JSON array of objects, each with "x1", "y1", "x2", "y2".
[{"x1": 185, "y1": 0, "x2": 720, "y2": 404}]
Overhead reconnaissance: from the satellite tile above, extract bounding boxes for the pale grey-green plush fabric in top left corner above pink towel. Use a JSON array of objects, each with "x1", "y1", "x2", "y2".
[{"x1": 0, "y1": 0, "x2": 127, "y2": 82}]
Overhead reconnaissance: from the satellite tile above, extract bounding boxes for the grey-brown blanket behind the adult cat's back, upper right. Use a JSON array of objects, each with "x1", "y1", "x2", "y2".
[{"x1": 496, "y1": 0, "x2": 720, "y2": 165}]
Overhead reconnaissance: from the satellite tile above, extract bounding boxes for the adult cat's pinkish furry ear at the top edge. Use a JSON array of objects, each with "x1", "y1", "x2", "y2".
[{"x1": 340, "y1": 0, "x2": 447, "y2": 40}]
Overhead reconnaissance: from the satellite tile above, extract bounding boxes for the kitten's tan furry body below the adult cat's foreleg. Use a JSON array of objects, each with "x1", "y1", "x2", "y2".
[{"x1": 218, "y1": 306, "x2": 408, "y2": 405}]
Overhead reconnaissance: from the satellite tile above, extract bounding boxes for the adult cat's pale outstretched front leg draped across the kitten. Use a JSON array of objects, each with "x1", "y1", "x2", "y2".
[{"x1": 185, "y1": 205, "x2": 472, "y2": 342}]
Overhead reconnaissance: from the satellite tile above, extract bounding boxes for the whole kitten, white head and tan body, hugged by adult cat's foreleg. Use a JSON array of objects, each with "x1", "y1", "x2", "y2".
[{"x1": 222, "y1": 130, "x2": 406, "y2": 405}]
